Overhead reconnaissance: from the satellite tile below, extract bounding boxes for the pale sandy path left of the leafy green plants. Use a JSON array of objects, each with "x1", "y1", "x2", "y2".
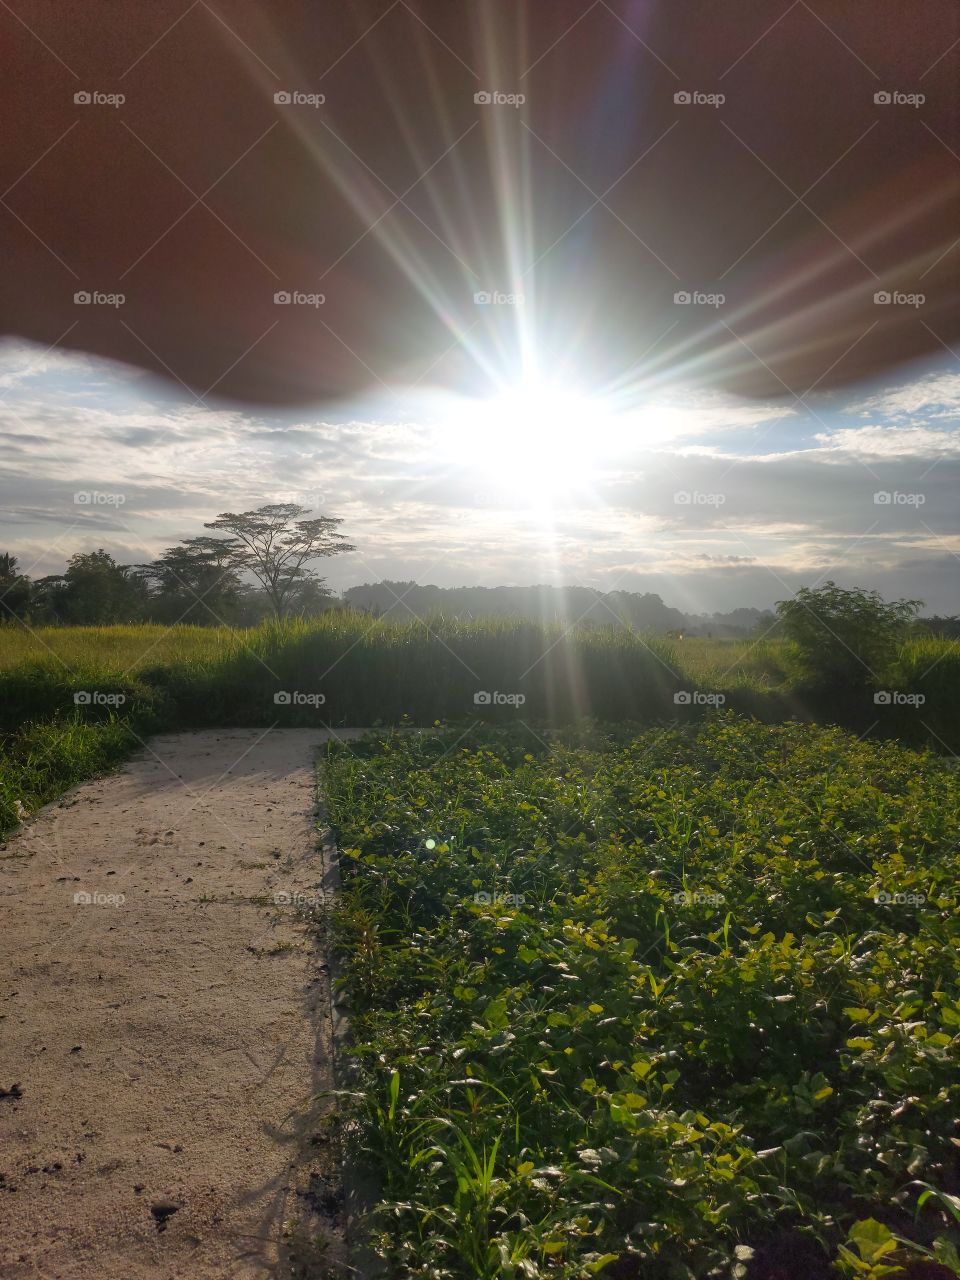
[{"x1": 0, "y1": 730, "x2": 360, "y2": 1280}]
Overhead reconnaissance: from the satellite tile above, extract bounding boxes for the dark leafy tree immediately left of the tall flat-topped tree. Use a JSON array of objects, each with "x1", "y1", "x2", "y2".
[{"x1": 137, "y1": 538, "x2": 243, "y2": 625}]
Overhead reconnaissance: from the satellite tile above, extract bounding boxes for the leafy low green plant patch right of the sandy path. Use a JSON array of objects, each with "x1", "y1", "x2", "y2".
[{"x1": 323, "y1": 717, "x2": 960, "y2": 1280}]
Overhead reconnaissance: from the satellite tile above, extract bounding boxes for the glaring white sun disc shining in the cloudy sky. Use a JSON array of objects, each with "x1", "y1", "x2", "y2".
[{"x1": 439, "y1": 379, "x2": 627, "y2": 507}]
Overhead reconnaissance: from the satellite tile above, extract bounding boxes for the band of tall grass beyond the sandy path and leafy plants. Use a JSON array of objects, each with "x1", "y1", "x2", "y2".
[{"x1": 0, "y1": 611, "x2": 960, "y2": 831}]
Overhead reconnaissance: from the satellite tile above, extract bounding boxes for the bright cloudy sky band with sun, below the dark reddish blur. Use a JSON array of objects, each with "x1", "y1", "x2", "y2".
[{"x1": 0, "y1": 343, "x2": 960, "y2": 613}]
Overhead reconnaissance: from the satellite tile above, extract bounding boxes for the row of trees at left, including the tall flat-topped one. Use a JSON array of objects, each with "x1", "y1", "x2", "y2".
[{"x1": 0, "y1": 503, "x2": 355, "y2": 626}]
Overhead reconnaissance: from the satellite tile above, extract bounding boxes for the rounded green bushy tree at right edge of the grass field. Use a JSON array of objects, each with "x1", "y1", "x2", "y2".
[{"x1": 777, "y1": 581, "x2": 923, "y2": 691}]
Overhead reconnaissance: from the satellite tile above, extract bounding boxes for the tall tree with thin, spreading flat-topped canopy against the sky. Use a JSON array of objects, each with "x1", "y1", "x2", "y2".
[{"x1": 204, "y1": 502, "x2": 356, "y2": 618}]
